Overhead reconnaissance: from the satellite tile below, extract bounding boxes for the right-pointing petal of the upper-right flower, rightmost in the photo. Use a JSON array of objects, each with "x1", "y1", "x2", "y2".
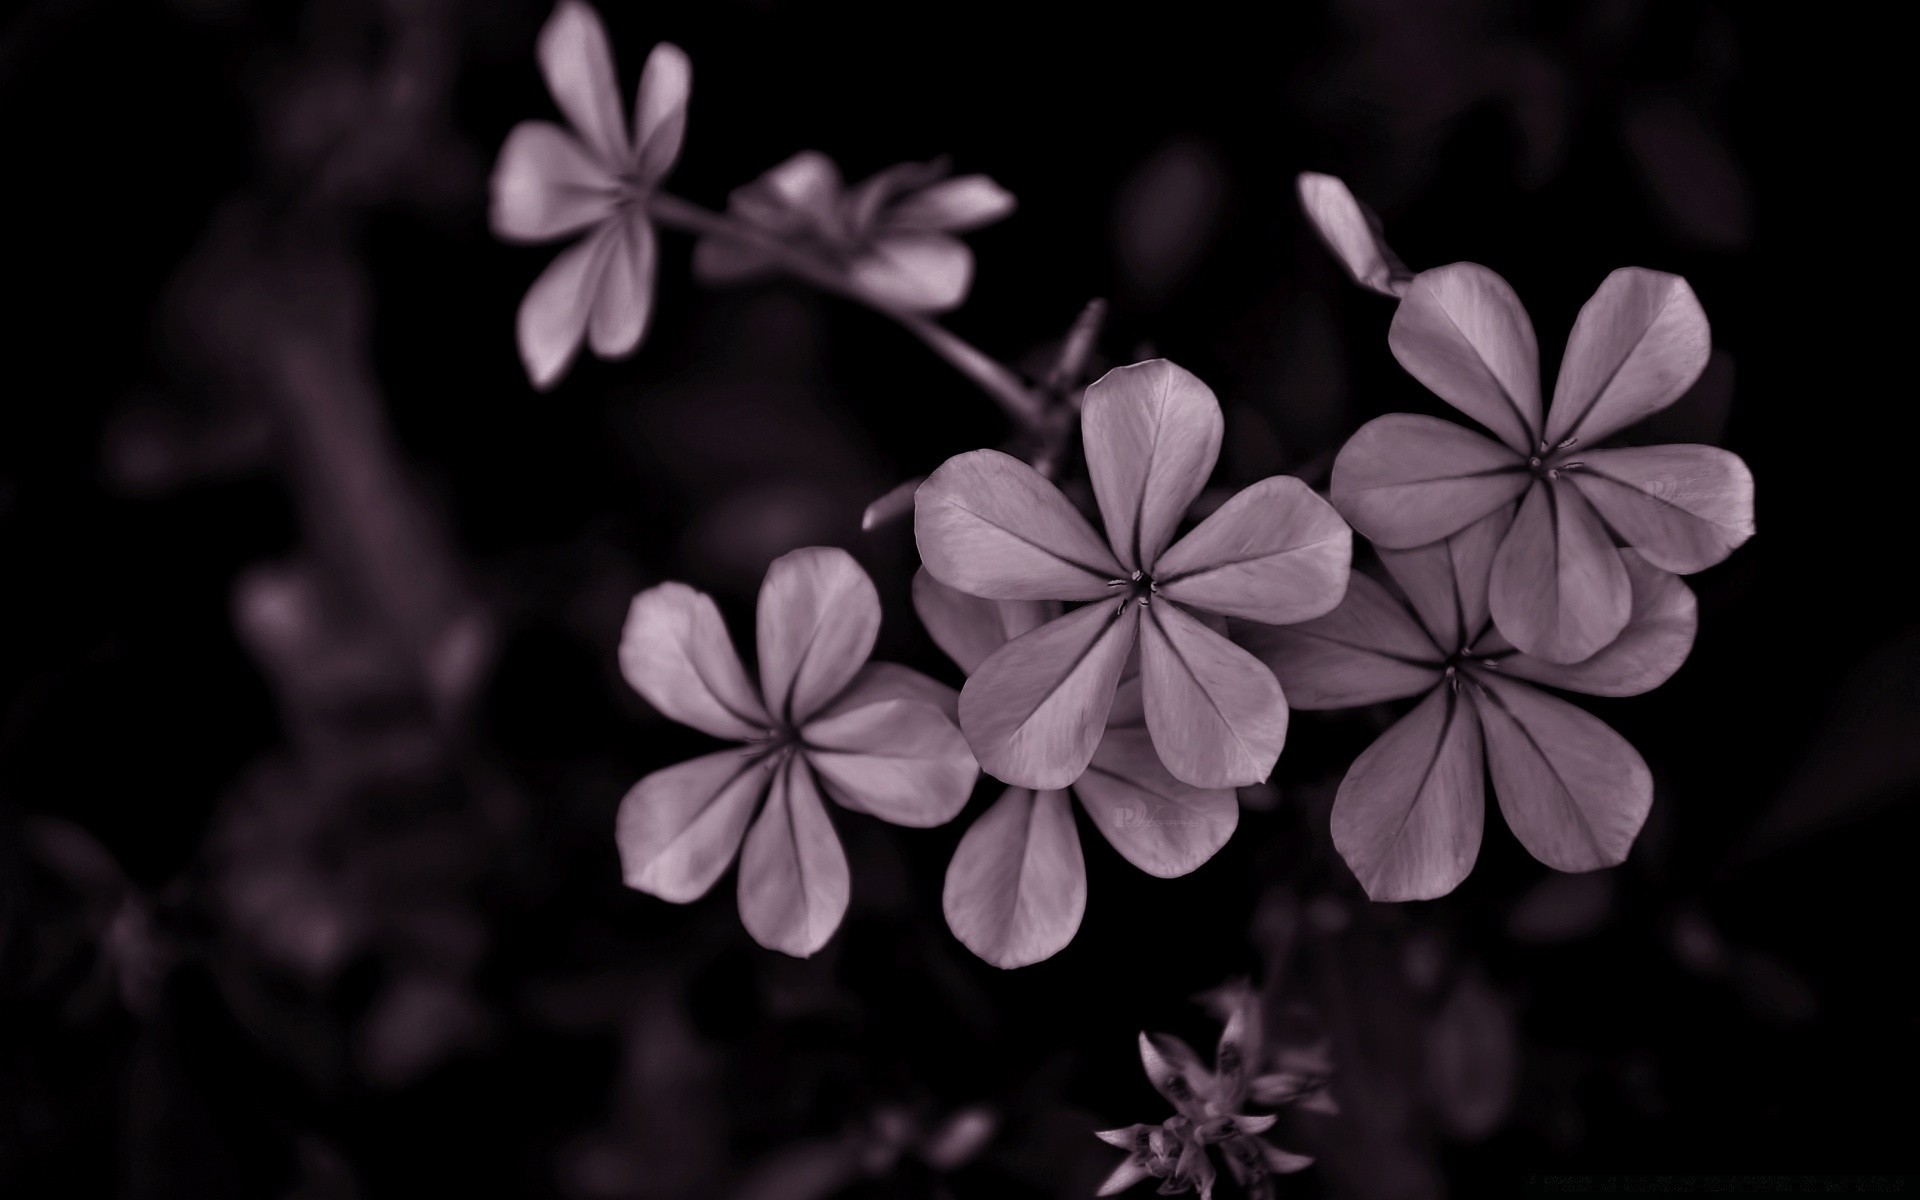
[{"x1": 1567, "y1": 445, "x2": 1753, "y2": 574}]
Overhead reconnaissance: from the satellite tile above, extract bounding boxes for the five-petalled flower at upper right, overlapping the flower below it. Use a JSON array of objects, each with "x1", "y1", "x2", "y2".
[{"x1": 1332, "y1": 263, "x2": 1753, "y2": 662}]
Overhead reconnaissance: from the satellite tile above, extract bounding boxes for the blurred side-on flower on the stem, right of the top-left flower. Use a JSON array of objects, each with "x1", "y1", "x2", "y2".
[{"x1": 693, "y1": 150, "x2": 1014, "y2": 313}]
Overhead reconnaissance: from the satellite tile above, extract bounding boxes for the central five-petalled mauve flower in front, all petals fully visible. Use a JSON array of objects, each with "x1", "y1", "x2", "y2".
[{"x1": 914, "y1": 359, "x2": 1352, "y2": 791}]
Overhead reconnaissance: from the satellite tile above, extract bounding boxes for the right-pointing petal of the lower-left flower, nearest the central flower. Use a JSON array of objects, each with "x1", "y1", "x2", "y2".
[{"x1": 801, "y1": 699, "x2": 979, "y2": 828}]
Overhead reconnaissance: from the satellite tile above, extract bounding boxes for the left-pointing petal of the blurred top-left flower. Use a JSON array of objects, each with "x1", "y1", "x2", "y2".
[{"x1": 488, "y1": 121, "x2": 616, "y2": 242}]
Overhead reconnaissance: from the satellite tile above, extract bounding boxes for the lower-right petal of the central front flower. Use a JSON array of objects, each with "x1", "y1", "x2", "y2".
[{"x1": 1140, "y1": 603, "x2": 1286, "y2": 787}]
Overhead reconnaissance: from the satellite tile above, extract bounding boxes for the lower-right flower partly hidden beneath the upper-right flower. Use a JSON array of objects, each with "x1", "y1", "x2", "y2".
[{"x1": 1242, "y1": 507, "x2": 1697, "y2": 900}]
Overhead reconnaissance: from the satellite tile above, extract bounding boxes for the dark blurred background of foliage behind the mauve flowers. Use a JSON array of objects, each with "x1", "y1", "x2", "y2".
[{"x1": 0, "y1": 0, "x2": 1920, "y2": 1200}]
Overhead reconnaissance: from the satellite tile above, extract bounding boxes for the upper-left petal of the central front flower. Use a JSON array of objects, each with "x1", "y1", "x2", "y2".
[{"x1": 914, "y1": 449, "x2": 1127, "y2": 599}]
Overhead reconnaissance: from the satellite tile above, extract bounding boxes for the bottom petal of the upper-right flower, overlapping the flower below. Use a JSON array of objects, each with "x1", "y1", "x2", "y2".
[{"x1": 1486, "y1": 480, "x2": 1634, "y2": 662}]
